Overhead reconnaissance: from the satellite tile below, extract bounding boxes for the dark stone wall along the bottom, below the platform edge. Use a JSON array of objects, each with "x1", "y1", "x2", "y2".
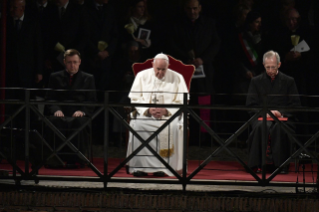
[{"x1": 0, "y1": 191, "x2": 319, "y2": 212}]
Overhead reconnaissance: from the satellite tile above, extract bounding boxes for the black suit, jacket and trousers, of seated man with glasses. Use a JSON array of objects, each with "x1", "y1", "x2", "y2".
[{"x1": 46, "y1": 70, "x2": 96, "y2": 164}]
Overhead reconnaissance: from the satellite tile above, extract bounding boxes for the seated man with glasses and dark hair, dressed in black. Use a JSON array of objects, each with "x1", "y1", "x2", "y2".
[{"x1": 46, "y1": 49, "x2": 96, "y2": 164}]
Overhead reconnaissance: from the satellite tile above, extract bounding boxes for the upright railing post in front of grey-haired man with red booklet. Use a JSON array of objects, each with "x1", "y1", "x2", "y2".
[{"x1": 261, "y1": 95, "x2": 268, "y2": 186}]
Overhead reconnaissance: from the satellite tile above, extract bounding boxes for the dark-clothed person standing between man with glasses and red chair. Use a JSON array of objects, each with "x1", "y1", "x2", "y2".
[{"x1": 84, "y1": 0, "x2": 118, "y2": 90}]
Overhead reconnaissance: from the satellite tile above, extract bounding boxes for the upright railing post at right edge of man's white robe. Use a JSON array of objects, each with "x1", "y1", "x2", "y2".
[{"x1": 182, "y1": 93, "x2": 188, "y2": 191}]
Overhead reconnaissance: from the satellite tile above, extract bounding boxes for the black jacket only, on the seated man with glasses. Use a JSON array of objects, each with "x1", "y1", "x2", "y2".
[{"x1": 46, "y1": 70, "x2": 96, "y2": 117}]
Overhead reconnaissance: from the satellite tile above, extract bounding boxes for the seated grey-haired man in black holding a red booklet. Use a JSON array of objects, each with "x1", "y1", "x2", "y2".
[{"x1": 246, "y1": 51, "x2": 300, "y2": 173}]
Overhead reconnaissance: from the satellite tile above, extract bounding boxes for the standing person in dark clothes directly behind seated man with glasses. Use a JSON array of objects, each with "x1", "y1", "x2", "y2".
[{"x1": 46, "y1": 0, "x2": 90, "y2": 71}]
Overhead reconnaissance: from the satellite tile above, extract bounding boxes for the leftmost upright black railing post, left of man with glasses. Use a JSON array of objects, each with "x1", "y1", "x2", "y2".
[{"x1": 24, "y1": 89, "x2": 30, "y2": 175}]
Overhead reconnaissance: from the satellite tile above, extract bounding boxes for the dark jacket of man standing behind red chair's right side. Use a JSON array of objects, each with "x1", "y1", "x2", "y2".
[{"x1": 169, "y1": 15, "x2": 220, "y2": 93}]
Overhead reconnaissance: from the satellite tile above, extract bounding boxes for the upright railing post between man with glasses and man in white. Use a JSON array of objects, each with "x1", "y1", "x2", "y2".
[{"x1": 103, "y1": 91, "x2": 109, "y2": 189}]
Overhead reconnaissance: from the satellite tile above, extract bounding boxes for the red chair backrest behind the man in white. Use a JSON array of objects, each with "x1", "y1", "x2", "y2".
[{"x1": 132, "y1": 55, "x2": 195, "y2": 92}]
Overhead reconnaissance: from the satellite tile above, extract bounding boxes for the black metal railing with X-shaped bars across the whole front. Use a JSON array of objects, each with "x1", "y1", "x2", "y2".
[{"x1": 0, "y1": 89, "x2": 319, "y2": 190}]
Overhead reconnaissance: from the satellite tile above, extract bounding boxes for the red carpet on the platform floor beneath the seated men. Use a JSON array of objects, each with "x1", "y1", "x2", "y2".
[{"x1": 0, "y1": 158, "x2": 317, "y2": 183}]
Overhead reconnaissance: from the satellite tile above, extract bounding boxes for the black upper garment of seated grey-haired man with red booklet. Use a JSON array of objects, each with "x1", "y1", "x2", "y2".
[{"x1": 246, "y1": 71, "x2": 300, "y2": 117}]
